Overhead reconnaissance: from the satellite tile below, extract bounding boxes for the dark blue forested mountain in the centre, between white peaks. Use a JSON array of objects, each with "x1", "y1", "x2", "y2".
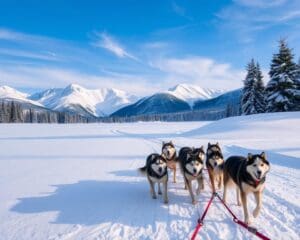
[{"x1": 111, "y1": 93, "x2": 191, "y2": 117}]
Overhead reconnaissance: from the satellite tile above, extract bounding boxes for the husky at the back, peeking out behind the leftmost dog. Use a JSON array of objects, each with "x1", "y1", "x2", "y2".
[{"x1": 161, "y1": 141, "x2": 177, "y2": 183}]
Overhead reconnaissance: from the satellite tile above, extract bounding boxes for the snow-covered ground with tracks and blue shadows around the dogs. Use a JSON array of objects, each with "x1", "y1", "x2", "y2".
[{"x1": 0, "y1": 112, "x2": 300, "y2": 240}]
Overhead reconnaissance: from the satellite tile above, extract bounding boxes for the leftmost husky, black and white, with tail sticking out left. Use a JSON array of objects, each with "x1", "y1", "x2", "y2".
[{"x1": 139, "y1": 153, "x2": 169, "y2": 203}]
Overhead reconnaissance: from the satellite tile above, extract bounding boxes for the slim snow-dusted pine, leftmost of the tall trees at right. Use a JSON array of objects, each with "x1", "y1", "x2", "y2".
[{"x1": 241, "y1": 59, "x2": 257, "y2": 115}]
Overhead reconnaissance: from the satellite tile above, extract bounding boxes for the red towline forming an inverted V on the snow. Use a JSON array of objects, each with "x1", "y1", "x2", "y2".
[{"x1": 191, "y1": 192, "x2": 271, "y2": 240}]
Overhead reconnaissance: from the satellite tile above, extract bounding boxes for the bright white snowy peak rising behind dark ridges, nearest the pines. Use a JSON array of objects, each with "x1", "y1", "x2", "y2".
[{"x1": 167, "y1": 84, "x2": 224, "y2": 107}]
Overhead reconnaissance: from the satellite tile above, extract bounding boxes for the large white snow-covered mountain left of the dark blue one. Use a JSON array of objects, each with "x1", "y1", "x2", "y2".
[{"x1": 29, "y1": 84, "x2": 136, "y2": 117}]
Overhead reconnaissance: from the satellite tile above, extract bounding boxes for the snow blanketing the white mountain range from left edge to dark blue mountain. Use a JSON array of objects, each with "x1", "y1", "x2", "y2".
[{"x1": 0, "y1": 84, "x2": 137, "y2": 116}]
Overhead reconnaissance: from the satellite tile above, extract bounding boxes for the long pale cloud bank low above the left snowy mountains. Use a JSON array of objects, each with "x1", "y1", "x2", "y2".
[{"x1": 0, "y1": 66, "x2": 160, "y2": 96}]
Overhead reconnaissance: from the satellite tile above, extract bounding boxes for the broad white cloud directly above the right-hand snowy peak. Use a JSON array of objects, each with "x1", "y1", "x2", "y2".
[{"x1": 150, "y1": 56, "x2": 245, "y2": 89}]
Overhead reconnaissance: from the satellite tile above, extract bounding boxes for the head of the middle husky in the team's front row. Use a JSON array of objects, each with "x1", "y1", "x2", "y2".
[{"x1": 185, "y1": 146, "x2": 205, "y2": 177}]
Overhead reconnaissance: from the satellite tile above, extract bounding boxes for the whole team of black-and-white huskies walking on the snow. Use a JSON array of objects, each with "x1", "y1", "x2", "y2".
[{"x1": 139, "y1": 141, "x2": 270, "y2": 224}]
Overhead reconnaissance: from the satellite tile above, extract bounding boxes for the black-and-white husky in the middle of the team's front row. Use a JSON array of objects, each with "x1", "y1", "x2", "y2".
[{"x1": 178, "y1": 146, "x2": 205, "y2": 204}]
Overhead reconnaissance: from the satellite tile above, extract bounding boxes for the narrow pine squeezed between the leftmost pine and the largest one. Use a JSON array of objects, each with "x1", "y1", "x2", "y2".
[{"x1": 254, "y1": 63, "x2": 266, "y2": 113}]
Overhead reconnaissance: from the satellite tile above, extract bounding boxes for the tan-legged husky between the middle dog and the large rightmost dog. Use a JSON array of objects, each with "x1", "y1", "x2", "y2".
[{"x1": 206, "y1": 143, "x2": 224, "y2": 192}]
